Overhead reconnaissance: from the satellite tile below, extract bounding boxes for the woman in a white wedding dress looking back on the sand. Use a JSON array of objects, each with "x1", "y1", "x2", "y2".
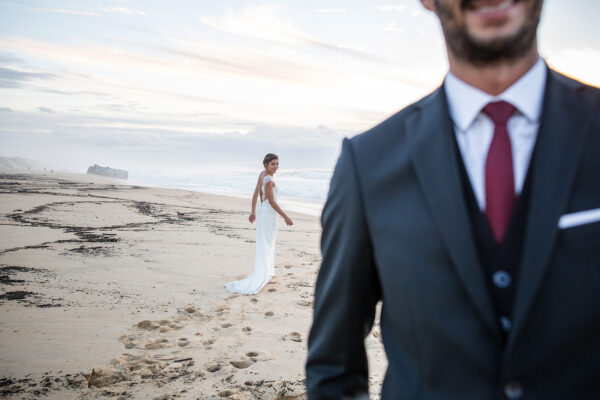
[{"x1": 225, "y1": 153, "x2": 293, "y2": 294}]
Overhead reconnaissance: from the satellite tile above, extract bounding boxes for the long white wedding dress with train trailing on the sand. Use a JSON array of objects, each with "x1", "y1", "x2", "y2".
[{"x1": 225, "y1": 175, "x2": 278, "y2": 294}]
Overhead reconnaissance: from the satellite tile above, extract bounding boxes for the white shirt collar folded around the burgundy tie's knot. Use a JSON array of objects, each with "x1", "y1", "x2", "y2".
[{"x1": 444, "y1": 58, "x2": 548, "y2": 131}]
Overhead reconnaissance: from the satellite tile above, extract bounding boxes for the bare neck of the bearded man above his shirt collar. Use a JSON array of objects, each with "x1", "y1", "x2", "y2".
[{"x1": 448, "y1": 44, "x2": 539, "y2": 96}]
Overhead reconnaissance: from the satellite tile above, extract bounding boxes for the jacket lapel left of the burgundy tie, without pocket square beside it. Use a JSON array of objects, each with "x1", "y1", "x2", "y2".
[{"x1": 405, "y1": 86, "x2": 500, "y2": 338}]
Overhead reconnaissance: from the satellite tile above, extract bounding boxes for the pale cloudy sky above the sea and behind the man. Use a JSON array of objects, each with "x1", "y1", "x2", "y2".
[{"x1": 0, "y1": 0, "x2": 600, "y2": 171}]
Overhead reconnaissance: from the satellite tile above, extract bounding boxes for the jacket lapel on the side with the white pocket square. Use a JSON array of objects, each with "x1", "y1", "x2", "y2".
[{"x1": 509, "y1": 71, "x2": 593, "y2": 350}]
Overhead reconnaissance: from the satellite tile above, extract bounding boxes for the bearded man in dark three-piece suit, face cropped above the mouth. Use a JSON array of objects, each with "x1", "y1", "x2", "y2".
[{"x1": 306, "y1": 0, "x2": 600, "y2": 400}]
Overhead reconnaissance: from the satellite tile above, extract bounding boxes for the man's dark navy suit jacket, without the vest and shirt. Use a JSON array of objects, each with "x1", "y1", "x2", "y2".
[{"x1": 306, "y1": 67, "x2": 600, "y2": 400}]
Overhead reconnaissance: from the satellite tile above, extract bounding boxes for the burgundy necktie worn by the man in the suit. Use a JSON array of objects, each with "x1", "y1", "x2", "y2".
[{"x1": 483, "y1": 101, "x2": 516, "y2": 243}]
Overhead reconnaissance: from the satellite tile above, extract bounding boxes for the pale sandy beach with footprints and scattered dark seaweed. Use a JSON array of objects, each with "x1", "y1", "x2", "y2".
[{"x1": 0, "y1": 174, "x2": 385, "y2": 399}]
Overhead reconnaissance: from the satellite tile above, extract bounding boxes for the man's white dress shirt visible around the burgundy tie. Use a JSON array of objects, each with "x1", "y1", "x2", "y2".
[{"x1": 444, "y1": 58, "x2": 547, "y2": 211}]
